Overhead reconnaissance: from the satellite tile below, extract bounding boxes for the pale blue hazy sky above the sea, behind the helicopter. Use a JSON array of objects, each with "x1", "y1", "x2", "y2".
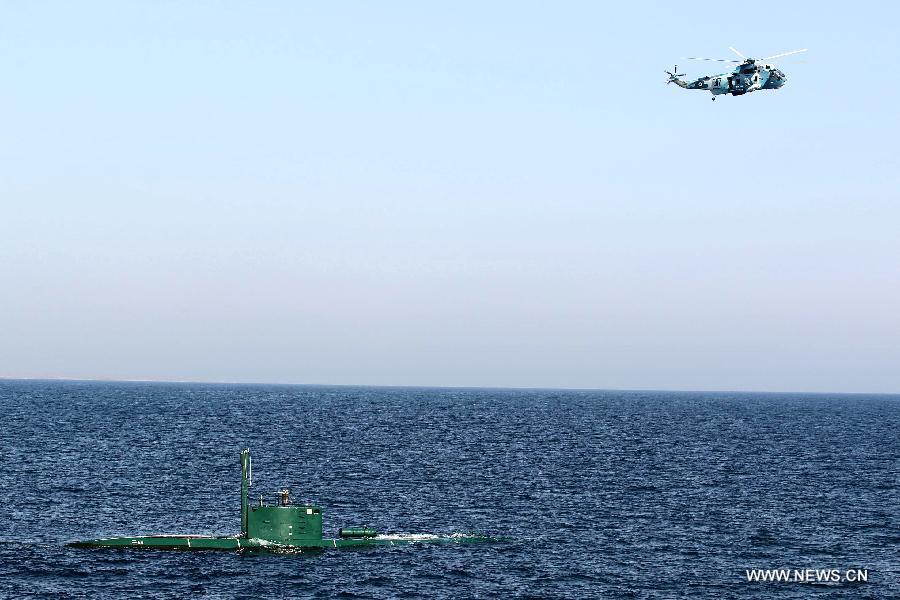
[{"x1": 0, "y1": 0, "x2": 900, "y2": 392}]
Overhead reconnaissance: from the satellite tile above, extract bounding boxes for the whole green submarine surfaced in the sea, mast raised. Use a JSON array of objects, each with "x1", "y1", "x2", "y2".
[{"x1": 68, "y1": 449, "x2": 500, "y2": 552}]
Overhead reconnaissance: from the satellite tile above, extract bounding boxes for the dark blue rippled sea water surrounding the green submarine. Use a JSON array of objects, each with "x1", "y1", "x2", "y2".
[{"x1": 0, "y1": 381, "x2": 900, "y2": 598}]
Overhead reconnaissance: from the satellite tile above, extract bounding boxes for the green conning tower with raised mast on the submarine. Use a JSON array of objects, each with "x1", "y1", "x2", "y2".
[{"x1": 241, "y1": 449, "x2": 322, "y2": 546}]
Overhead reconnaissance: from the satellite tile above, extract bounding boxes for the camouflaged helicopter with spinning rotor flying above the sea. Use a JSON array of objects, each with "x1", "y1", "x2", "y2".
[{"x1": 666, "y1": 46, "x2": 806, "y2": 100}]
